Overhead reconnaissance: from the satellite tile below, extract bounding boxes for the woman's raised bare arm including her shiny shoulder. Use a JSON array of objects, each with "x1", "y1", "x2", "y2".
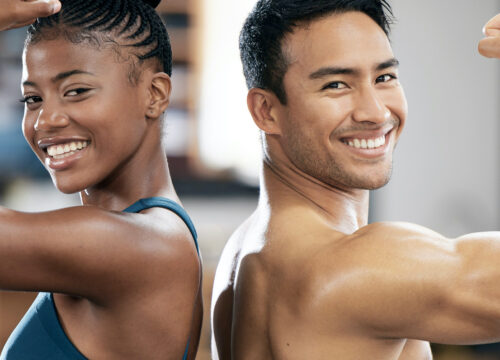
[{"x1": 0, "y1": 202, "x2": 198, "y2": 301}]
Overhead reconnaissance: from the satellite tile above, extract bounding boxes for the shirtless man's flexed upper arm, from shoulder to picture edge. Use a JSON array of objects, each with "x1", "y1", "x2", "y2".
[{"x1": 320, "y1": 224, "x2": 500, "y2": 343}]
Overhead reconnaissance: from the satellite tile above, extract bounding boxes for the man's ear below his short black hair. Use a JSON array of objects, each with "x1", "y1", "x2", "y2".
[{"x1": 247, "y1": 88, "x2": 283, "y2": 135}]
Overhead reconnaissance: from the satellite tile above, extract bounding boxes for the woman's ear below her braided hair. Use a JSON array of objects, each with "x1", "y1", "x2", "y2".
[{"x1": 146, "y1": 72, "x2": 172, "y2": 119}]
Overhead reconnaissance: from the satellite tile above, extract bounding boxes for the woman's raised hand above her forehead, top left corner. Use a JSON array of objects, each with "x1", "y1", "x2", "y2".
[{"x1": 0, "y1": 0, "x2": 61, "y2": 30}]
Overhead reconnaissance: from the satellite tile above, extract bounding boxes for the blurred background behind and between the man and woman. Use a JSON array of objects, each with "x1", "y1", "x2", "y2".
[{"x1": 0, "y1": 0, "x2": 500, "y2": 360}]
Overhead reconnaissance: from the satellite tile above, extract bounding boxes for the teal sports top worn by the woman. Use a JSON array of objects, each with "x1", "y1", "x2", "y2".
[{"x1": 0, "y1": 197, "x2": 199, "y2": 360}]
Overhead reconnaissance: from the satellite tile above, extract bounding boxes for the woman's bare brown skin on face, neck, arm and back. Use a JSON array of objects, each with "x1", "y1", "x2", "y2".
[{"x1": 0, "y1": 38, "x2": 202, "y2": 359}]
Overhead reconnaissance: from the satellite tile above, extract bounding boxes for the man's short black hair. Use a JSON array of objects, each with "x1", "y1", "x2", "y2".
[{"x1": 240, "y1": 0, "x2": 392, "y2": 104}]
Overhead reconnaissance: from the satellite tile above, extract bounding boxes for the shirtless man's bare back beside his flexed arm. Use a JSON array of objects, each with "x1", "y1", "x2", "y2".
[{"x1": 212, "y1": 167, "x2": 432, "y2": 360}]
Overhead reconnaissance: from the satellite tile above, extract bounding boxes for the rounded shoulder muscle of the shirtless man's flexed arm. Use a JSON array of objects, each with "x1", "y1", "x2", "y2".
[{"x1": 300, "y1": 222, "x2": 457, "y2": 337}]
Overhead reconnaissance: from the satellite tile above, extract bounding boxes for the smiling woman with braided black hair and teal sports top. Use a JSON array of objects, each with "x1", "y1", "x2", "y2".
[{"x1": 0, "y1": 0, "x2": 202, "y2": 360}]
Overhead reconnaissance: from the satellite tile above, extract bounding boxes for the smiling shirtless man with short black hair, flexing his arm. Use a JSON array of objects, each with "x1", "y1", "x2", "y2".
[{"x1": 212, "y1": 0, "x2": 500, "y2": 360}]
